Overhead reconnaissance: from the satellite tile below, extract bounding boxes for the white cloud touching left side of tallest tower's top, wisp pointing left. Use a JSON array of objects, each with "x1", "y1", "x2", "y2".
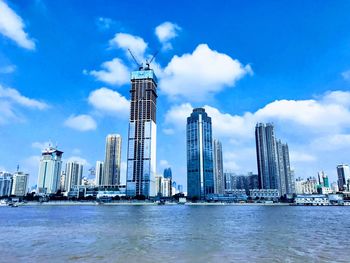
[{"x1": 89, "y1": 58, "x2": 130, "y2": 85}]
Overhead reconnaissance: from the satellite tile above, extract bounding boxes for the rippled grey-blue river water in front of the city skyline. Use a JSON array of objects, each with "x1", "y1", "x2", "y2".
[{"x1": 0, "y1": 205, "x2": 350, "y2": 263}]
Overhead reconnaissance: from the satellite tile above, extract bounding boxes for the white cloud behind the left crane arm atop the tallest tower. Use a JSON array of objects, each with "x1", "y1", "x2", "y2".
[{"x1": 109, "y1": 33, "x2": 148, "y2": 60}]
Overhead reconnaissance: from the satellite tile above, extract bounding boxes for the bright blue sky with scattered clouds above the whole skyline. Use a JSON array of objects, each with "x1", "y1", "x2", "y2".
[{"x1": 0, "y1": 0, "x2": 350, "y2": 189}]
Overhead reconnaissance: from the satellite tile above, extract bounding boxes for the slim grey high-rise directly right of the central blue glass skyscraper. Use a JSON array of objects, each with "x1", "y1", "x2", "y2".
[{"x1": 213, "y1": 139, "x2": 225, "y2": 194}]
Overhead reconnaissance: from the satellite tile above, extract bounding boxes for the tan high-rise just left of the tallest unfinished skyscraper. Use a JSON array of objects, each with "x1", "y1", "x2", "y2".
[{"x1": 101, "y1": 134, "x2": 122, "y2": 185}]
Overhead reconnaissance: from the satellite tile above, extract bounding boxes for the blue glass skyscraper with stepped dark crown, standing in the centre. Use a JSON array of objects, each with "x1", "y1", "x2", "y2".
[{"x1": 186, "y1": 108, "x2": 214, "y2": 199}]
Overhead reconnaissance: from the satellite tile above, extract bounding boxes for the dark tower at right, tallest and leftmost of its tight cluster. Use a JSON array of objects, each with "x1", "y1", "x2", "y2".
[{"x1": 255, "y1": 123, "x2": 280, "y2": 192}]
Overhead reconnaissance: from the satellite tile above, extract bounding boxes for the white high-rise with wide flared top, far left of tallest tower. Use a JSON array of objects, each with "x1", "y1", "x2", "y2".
[{"x1": 37, "y1": 146, "x2": 63, "y2": 194}]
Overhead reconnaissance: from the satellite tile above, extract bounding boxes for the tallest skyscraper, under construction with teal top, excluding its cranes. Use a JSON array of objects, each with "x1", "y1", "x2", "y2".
[{"x1": 126, "y1": 67, "x2": 157, "y2": 197}]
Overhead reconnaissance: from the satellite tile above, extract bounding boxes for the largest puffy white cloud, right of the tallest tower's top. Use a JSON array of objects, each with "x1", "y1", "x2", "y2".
[{"x1": 159, "y1": 44, "x2": 252, "y2": 101}]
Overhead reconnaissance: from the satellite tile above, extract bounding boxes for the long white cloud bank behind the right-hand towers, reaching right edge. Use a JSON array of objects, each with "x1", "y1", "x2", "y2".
[{"x1": 165, "y1": 91, "x2": 350, "y2": 139}]
